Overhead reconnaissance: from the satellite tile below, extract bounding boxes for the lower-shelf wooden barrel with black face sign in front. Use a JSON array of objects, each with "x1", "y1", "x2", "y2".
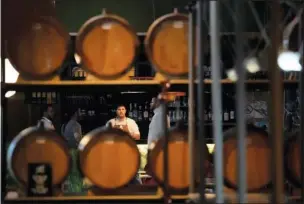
[{"x1": 7, "y1": 127, "x2": 72, "y2": 187}]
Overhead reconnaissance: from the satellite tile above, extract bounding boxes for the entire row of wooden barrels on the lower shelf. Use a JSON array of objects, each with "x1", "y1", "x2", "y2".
[{"x1": 7, "y1": 121, "x2": 301, "y2": 192}]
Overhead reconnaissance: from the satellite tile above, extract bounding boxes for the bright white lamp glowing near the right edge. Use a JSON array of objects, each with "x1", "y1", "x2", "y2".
[{"x1": 277, "y1": 51, "x2": 302, "y2": 72}]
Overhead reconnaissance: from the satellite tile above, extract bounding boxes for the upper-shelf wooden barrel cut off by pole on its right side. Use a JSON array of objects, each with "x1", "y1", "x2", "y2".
[{"x1": 145, "y1": 9, "x2": 189, "y2": 78}]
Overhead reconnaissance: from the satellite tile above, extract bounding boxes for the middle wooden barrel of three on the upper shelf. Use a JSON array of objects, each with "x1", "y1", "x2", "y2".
[{"x1": 76, "y1": 10, "x2": 139, "y2": 79}]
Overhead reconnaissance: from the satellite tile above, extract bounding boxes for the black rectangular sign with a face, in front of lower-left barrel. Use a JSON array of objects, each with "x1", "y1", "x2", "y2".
[{"x1": 27, "y1": 163, "x2": 52, "y2": 196}]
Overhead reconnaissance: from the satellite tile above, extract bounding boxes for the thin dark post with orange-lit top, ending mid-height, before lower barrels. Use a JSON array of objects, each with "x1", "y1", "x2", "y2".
[{"x1": 160, "y1": 83, "x2": 170, "y2": 204}]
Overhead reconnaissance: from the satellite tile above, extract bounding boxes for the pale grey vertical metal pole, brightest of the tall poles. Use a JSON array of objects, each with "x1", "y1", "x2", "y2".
[{"x1": 209, "y1": 1, "x2": 224, "y2": 203}]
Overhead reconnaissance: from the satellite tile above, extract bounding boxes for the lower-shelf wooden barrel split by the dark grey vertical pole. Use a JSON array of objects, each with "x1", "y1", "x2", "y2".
[{"x1": 223, "y1": 125, "x2": 271, "y2": 192}]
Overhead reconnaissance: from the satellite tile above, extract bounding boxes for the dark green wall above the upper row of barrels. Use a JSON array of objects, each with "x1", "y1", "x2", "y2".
[{"x1": 56, "y1": 0, "x2": 268, "y2": 32}]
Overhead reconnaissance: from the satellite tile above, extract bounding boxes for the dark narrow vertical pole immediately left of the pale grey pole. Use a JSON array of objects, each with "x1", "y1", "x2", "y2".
[{"x1": 196, "y1": 0, "x2": 208, "y2": 204}]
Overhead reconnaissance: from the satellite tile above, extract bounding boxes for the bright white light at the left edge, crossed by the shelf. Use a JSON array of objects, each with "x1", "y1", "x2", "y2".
[{"x1": 0, "y1": 58, "x2": 19, "y2": 98}]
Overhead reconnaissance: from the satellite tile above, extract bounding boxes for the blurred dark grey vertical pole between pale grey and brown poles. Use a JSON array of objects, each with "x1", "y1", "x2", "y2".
[{"x1": 234, "y1": 0, "x2": 247, "y2": 203}]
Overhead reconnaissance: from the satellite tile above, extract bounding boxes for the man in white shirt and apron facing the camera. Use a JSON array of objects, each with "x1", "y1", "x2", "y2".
[{"x1": 106, "y1": 105, "x2": 140, "y2": 140}]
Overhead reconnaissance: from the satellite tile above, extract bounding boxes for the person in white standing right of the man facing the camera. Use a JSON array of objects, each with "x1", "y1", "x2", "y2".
[{"x1": 148, "y1": 97, "x2": 170, "y2": 147}]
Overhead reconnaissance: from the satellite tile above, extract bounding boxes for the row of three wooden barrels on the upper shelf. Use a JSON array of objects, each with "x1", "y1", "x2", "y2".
[{"x1": 4, "y1": 0, "x2": 188, "y2": 80}]
